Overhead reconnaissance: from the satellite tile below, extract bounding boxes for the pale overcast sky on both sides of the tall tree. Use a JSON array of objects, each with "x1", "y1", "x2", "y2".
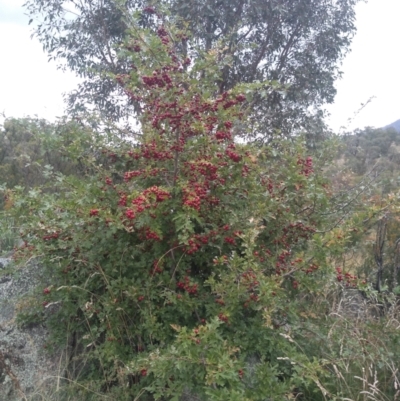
[{"x1": 0, "y1": 0, "x2": 400, "y2": 130}]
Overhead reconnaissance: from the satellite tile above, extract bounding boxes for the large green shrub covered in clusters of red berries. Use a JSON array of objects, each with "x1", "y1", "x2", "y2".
[{"x1": 7, "y1": 10, "x2": 388, "y2": 401}]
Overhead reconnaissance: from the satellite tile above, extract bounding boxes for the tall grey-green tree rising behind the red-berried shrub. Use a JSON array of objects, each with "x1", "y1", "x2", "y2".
[{"x1": 26, "y1": 0, "x2": 359, "y2": 138}]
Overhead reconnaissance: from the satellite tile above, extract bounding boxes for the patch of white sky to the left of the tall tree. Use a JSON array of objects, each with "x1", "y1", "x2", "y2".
[{"x1": 0, "y1": 0, "x2": 78, "y2": 120}]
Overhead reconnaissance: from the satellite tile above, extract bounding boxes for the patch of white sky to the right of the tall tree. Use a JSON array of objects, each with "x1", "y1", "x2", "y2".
[{"x1": 327, "y1": 0, "x2": 400, "y2": 129}]
